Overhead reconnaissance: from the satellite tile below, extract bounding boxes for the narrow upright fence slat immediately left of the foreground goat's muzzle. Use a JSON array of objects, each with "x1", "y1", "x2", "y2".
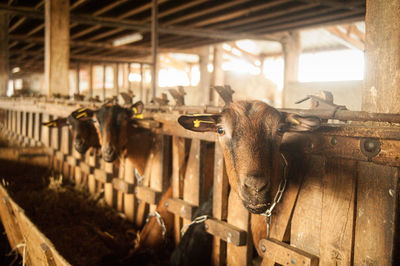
[{"x1": 212, "y1": 143, "x2": 228, "y2": 265}]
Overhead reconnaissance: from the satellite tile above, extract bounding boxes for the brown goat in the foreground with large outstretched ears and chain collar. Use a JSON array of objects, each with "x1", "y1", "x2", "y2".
[{"x1": 178, "y1": 101, "x2": 320, "y2": 254}]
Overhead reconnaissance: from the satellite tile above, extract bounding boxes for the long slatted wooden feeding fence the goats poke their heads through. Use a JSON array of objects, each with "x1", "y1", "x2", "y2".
[{"x1": 0, "y1": 100, "x2": 400, "y2": 265}]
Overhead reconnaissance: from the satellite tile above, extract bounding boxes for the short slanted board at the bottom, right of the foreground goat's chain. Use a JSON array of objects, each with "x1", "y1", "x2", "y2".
[{"x1": 260, "y1": 239, "x2": 318, "y2": 266}]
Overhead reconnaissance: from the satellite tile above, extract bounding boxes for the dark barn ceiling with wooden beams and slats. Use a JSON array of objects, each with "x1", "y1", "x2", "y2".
[{"x1": 0, "y1": 0, "x2": 365, "y2": 71}]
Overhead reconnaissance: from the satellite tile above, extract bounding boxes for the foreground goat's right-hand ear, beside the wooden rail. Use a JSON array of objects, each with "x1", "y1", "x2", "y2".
[{"x1": 281, "y1": 113, "x2": 321, "y2": 131}]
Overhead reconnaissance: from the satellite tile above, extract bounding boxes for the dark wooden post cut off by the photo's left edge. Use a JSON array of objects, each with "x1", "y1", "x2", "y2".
[{"x1": 0, "y1": 12, "x2": 8, "y2": 96}]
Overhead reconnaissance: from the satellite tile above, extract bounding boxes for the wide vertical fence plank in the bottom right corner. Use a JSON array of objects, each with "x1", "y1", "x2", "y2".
[{"x1": 353, "y1": 162, "x2": 399, "y2": 265}]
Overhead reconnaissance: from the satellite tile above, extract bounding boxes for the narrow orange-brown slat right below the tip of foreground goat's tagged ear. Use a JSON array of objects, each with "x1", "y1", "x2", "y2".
[{"x1": 171, "y1": 136, "x2": 186, "y2": 245}]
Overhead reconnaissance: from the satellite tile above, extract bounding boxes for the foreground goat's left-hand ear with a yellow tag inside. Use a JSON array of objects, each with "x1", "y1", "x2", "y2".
[{"x1": 178, "y1": 115, "x2": 220, "y2": 132}]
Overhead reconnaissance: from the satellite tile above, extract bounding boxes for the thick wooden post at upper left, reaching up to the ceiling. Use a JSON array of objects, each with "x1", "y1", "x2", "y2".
[{"x1": 44, "y1": 0, "x2": 69, "y2": 95}]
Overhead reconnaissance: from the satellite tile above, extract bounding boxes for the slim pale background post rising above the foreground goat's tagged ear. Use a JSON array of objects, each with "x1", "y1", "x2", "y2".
[{"x1": 210, "y1": 44, "x2": 224, "y2": 106}]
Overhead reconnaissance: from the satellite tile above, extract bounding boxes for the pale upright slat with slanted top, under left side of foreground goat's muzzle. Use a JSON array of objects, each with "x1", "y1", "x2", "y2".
[{"x1": 227, "y1": 190, "x2": 253, "y2": 265}]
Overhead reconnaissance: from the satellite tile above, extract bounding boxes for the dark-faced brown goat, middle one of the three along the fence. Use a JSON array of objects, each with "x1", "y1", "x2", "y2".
[{"x1": 75, "y1": 102, "x2": 174, "y2": 255}]
